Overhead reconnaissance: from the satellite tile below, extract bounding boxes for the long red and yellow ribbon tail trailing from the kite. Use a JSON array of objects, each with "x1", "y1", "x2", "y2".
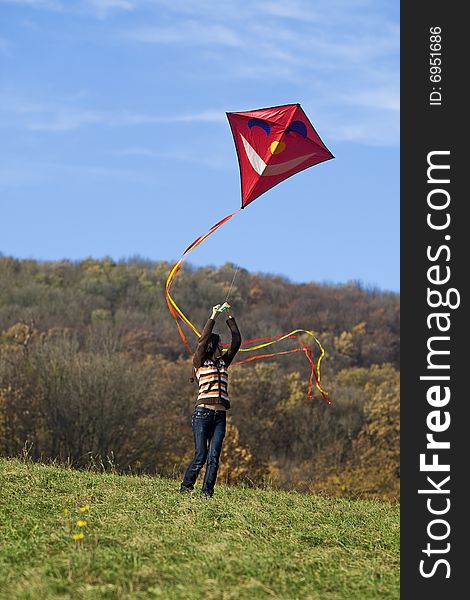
[{"x1": 165, "y1": 208, "x2": 332, "y2": 404}]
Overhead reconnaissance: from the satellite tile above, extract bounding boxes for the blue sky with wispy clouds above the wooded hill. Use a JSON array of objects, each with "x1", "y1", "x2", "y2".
[{"x1": 0, "y1": 0, "x2": 399, "y2": 291}]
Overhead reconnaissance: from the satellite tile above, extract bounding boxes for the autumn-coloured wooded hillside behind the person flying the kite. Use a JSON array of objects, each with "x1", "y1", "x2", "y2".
[{"x1": 0, "y1": 257, "x2": 399, "y2": 498}]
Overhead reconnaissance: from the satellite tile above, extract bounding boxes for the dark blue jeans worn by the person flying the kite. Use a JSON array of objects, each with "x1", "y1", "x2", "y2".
[{"x1": 181, "y1": 406, "x2": 226, "y2": 496}]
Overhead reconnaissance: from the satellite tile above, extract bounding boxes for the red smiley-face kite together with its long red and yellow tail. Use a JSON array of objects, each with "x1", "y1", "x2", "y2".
[{"x1": 165, "y1": 104, "x2": 334, "y2": 404}]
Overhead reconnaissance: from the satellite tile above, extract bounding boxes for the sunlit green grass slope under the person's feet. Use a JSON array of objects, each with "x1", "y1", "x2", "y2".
[{"x1": 0, "y1": 459, "x2": 399, "y2": 600}]
